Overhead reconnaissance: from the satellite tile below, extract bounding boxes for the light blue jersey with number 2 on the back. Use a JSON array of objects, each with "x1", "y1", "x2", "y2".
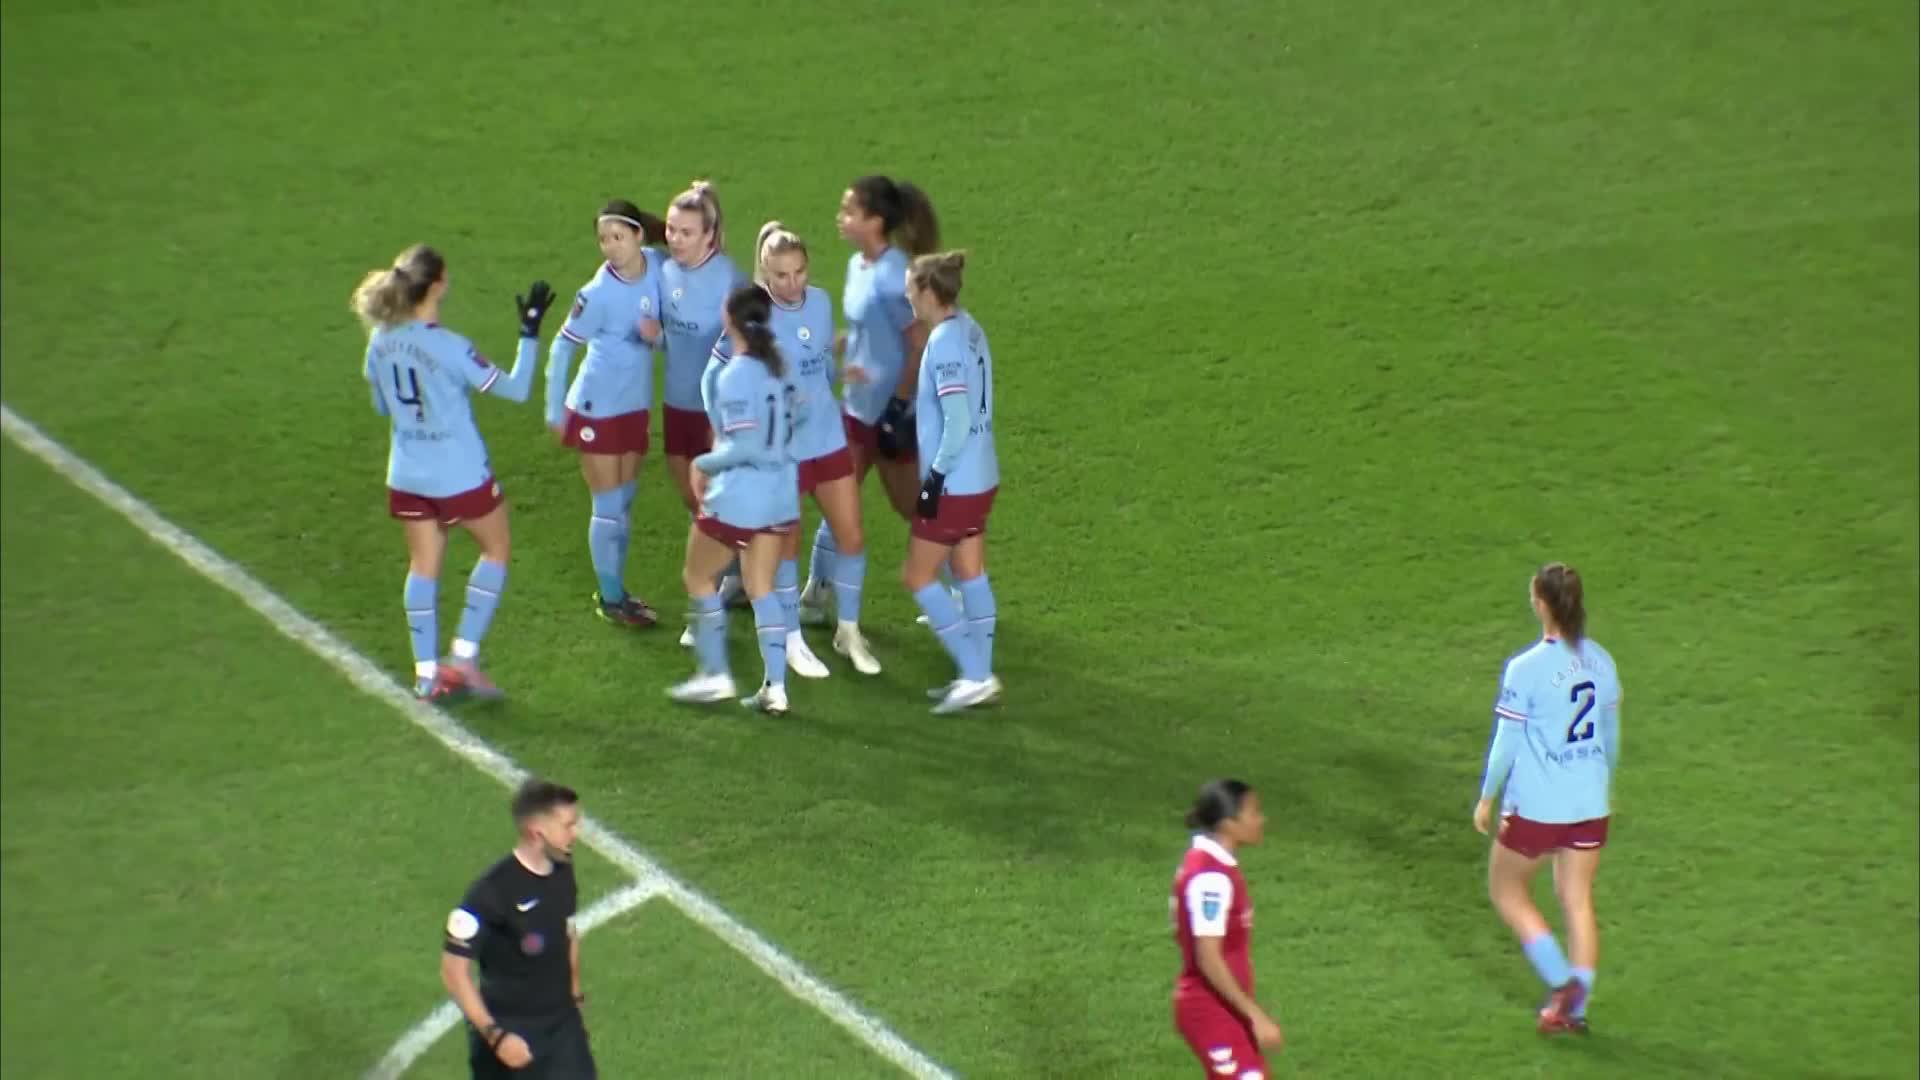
[{"x1": 1494, "y1": 638, "x2": 1620, "y2": 824}]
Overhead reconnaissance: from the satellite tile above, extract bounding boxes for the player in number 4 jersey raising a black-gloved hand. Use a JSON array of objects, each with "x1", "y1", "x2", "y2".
[{"x1": 351, "y1": 244, "x2": 553, "y2": 698}]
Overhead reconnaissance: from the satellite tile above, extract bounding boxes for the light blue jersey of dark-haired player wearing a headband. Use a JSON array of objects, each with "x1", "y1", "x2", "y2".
[{"x1": 561, "y1": 252, "x2": 660, "y2": 419}]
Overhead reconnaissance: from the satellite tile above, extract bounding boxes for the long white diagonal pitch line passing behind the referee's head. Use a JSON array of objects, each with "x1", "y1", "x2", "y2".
[{"x1": 0, "y1": 404, "x2": 952, "y2": 1080}]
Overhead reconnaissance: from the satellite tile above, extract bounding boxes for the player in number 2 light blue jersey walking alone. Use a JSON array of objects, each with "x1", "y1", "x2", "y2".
[{"x1": 1473, "y1": 563, "x2": 1620, "y2": 1034}]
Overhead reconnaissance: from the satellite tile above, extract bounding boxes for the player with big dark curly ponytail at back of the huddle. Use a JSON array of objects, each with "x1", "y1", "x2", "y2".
[{"x1": 801, "y1": 177, "x2": 941, "y2": 611}]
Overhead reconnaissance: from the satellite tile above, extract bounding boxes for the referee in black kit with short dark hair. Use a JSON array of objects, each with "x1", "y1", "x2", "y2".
[{"x1": 440, "y1": 780, "x2": 597, "y2": 1080}]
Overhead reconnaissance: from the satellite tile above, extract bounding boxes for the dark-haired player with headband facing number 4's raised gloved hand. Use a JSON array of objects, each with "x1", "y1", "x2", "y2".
[{"x1": 547, "y1": 198, "x2": 666, "y2": 626}]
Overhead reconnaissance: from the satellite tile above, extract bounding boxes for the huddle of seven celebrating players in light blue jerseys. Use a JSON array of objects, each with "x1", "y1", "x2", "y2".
[{"x1": 351, "y1": 175, "x2": 1000, "y2": 715}]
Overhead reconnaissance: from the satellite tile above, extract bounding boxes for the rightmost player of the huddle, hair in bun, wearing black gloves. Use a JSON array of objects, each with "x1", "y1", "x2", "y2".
[{"x1": 902, "y1": 252, "x2": 1000, "y2": 713}]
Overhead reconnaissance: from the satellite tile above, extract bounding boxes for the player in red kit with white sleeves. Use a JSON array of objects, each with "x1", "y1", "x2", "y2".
[{"x1": 1171, "y1": 780, "x2": 1281, "y2": 1080}]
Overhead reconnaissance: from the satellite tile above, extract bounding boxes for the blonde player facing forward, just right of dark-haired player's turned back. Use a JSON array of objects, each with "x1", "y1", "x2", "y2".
[{"x1": 753, "y1": 221, "x2": 879, "y2": 678}]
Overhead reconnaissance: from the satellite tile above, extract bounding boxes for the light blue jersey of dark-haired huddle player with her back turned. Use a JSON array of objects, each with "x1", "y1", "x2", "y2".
[{"x1": 705, "y1": 356, "x2": 801, "y2": 528}]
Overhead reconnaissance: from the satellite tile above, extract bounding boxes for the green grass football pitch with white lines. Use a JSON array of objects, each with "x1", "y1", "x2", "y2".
[{"x1": 0, "y1": 0, "x2": 1920, "y2": 1080}]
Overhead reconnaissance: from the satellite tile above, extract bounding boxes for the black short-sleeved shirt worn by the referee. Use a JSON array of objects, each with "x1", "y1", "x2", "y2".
[{"x1": 442, "y1": 853, "x2": 580, "y2": 1019}]
